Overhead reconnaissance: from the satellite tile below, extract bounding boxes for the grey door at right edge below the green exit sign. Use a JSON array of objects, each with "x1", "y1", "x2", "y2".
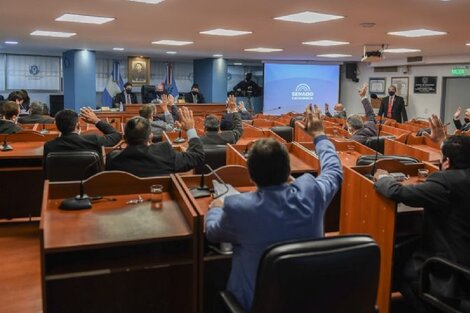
[{"x1": 441, "y1": 77, "x2": 470, "y2": 134}]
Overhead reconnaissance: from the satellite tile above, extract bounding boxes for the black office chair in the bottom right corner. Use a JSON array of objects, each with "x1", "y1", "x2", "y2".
[{"x1": 419, "y1": 257, "x2": 470, "y2": 313}]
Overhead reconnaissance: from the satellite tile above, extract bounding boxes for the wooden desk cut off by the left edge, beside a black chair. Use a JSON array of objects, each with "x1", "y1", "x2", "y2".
[{"x1": 0, "y1": 141, "x2": 44, "y2": 219}]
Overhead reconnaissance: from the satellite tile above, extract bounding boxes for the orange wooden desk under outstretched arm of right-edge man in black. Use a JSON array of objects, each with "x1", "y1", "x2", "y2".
[{"x1": 340, "y1": 160, "x2": 436, "y2": 313}]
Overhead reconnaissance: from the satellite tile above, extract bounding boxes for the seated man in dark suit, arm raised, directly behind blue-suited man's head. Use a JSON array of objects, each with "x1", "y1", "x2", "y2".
[{"x1": 201, "y1": 96, "x2": 243, "y2": 145}]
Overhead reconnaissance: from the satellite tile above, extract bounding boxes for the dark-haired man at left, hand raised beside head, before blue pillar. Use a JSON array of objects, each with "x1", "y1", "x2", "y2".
[{"x1": 44, "y1": 108, "x2": 122, "y2": 164}]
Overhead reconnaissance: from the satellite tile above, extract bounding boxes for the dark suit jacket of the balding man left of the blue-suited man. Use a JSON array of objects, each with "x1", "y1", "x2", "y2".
[{"x1": 106, "y1": 138, "x2": 204, "y2": 177}]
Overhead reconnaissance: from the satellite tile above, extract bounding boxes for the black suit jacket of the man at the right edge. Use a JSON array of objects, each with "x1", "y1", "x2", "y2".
[{"x1": 375, "y1": 169, "x2": 470, "y2": 296}]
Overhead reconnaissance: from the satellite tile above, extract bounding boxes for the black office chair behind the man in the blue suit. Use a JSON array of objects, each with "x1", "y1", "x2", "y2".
[{"x1": 221, "y1": 235, "x2": 380, "y2": 313}]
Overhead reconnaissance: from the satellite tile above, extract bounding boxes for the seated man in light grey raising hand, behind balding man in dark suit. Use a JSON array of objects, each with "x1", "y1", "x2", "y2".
[{"x1": 139, "y1": 95, "x2": 175, "y2": 141}]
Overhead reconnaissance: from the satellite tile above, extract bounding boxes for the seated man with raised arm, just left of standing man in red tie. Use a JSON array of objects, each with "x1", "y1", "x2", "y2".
[{"x1": 346, "y1": 84, "x2": 377, "y2": 144}]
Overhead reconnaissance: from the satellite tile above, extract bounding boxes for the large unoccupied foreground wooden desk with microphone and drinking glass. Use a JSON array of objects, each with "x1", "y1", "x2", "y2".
[{"x1": 40, "y1": 172, "x2": 200, "y2": 313}]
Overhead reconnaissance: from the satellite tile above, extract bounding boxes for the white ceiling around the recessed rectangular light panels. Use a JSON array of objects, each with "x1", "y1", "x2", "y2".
[{"x1": 0, "y1": 0, "x2": 470, "y2": 61}]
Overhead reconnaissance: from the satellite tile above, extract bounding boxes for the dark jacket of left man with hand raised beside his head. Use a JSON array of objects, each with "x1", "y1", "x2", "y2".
[{"x1": 44, "y1": 121, "x2": 122, "y2": 164}]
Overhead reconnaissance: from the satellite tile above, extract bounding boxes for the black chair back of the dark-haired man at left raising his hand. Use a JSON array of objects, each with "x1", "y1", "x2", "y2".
[{"x1": 45, "y1": 151, "x2": 103, "y2": 181}]
